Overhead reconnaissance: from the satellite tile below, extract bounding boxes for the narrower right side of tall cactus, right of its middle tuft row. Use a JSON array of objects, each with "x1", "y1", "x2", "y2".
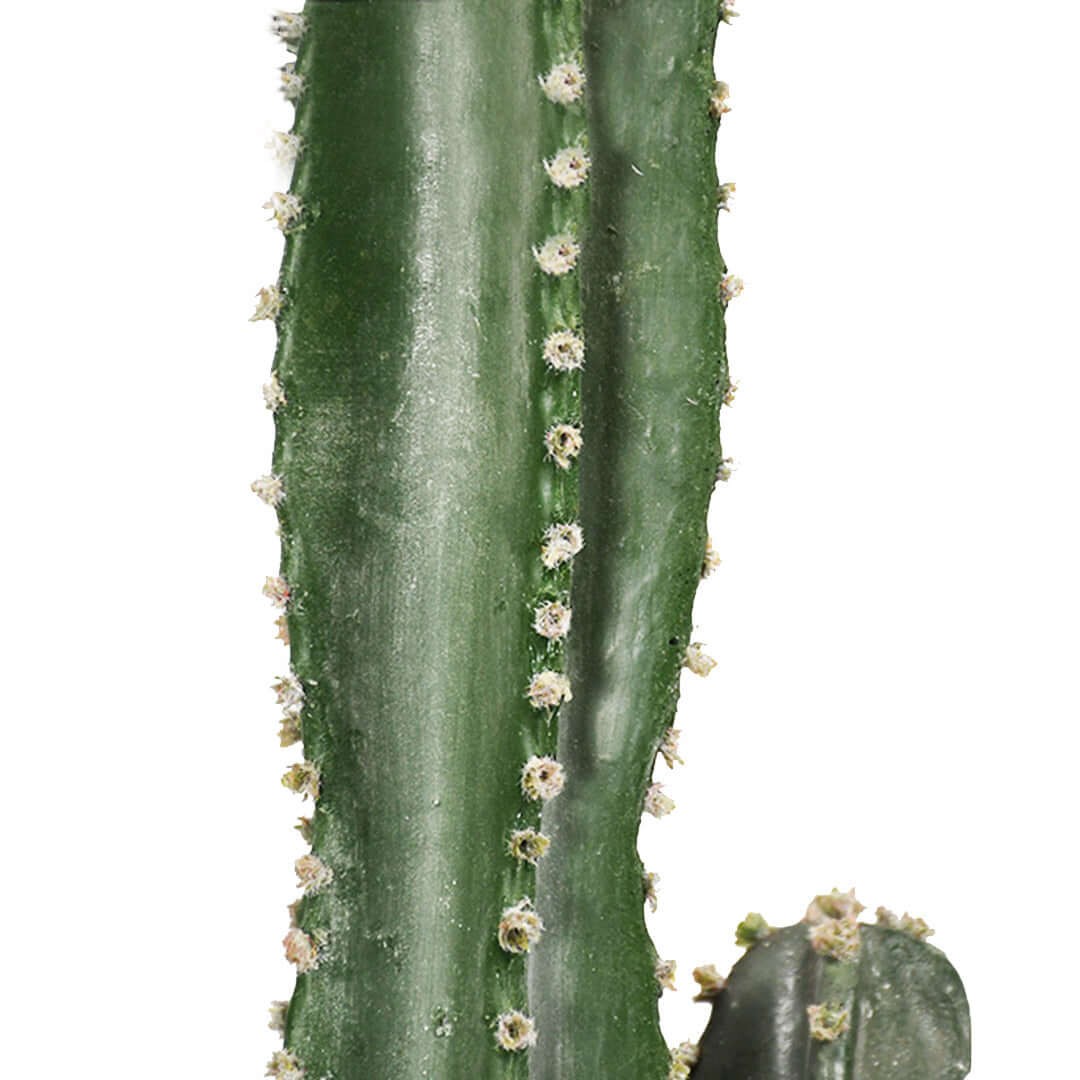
[{"x1": 529, "y1": 0, "x2": 728, "y2": 1080}]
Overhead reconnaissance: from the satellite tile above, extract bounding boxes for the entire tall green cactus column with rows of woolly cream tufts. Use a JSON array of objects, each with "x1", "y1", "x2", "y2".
[{"x1": 252, "y1": 0, "x2": 972, "y2": 1080}]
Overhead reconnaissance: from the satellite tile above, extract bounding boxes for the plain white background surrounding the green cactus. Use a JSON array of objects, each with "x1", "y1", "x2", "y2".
[{"x1": 0, "y1": 0, "x2": 1080, "y2": 1080}]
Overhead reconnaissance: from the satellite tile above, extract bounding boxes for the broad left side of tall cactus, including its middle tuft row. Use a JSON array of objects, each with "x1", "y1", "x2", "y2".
[{"x1": 254, "y1": 0, "x2": 580, "y2": 1080}]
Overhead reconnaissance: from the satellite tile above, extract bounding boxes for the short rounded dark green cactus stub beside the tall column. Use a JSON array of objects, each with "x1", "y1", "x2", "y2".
[{"x1": 690, "y1": 922, "x2": 971, "y2": 1080}]
